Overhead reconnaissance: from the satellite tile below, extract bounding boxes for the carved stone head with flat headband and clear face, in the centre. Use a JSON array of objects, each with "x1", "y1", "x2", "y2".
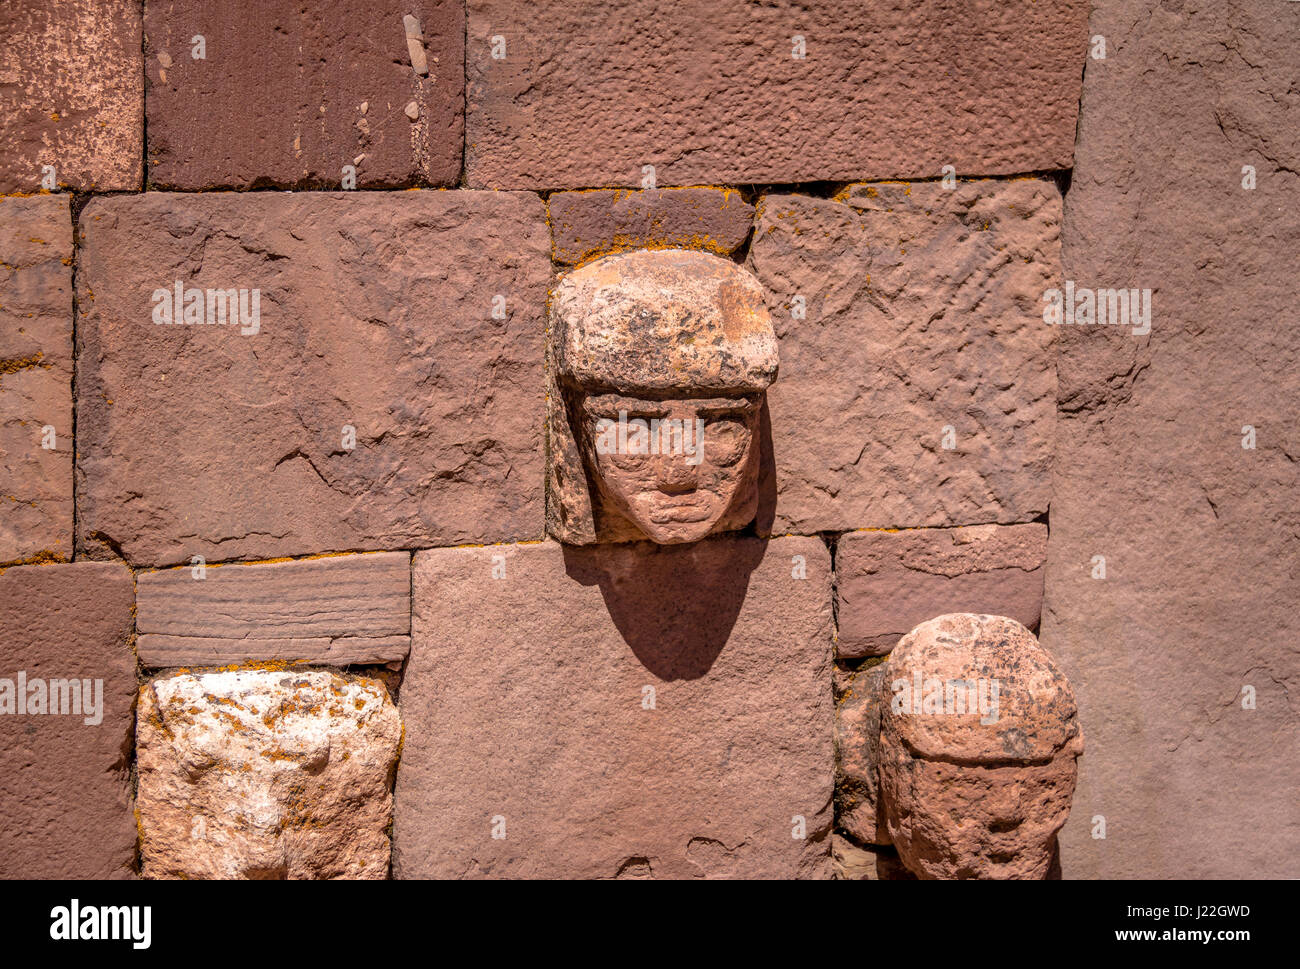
[{"x1": 547, "y1": 250, "x2": 776, "y2": 545}]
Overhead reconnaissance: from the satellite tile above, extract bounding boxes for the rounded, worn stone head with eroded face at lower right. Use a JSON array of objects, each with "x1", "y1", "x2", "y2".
[{"x1": 879, "y1": 613, "x2": 1083, "y2": 879}]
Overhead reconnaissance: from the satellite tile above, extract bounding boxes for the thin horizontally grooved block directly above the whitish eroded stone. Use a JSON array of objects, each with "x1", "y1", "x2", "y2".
[{"x1": 135, "y1": 551, "x2": 411, "y2": 667}]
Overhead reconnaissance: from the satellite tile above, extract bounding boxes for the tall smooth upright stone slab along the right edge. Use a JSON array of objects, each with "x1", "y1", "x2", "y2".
[{"x1": 1043, "y1": 0, "x2": 1300, "y2": 879}]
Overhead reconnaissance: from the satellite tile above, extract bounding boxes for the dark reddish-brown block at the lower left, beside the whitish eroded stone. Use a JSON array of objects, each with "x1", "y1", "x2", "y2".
[{"x1": 0, "y1": 562, "x2": 135, "y2": 879}]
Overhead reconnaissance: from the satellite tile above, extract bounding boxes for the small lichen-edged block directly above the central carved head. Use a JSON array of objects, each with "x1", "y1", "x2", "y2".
[{"x1": 546, "y1": 187, "x2": 754, "y2": 264}]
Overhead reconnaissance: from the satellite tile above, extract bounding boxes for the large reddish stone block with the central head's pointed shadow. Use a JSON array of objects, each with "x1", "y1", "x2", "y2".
[{"x1": 394, "y1": 537, "x2": 833, "y2": 878}]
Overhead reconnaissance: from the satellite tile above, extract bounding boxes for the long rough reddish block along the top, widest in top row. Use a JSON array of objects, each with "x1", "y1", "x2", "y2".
[{"x1": 465, "y1": 0, "x2": 1088, "y2": 189}]
